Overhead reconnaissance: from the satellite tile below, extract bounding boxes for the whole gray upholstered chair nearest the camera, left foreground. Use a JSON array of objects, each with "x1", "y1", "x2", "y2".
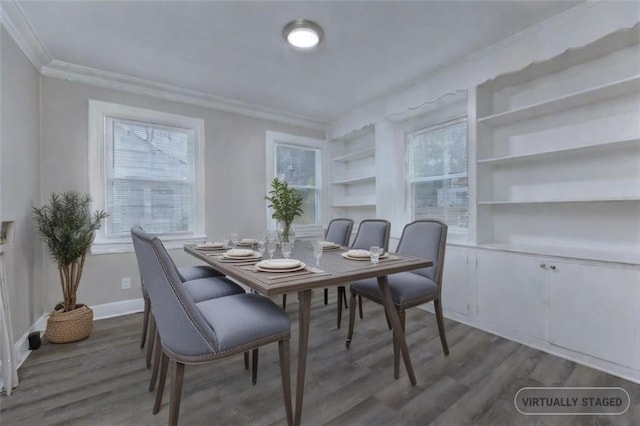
[{"x1": 131, "y1": 228, "x2": 293, "y2": 425}]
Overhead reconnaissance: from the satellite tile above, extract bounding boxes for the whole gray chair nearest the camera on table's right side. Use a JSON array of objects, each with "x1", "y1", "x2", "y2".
[{"x1": 347, "y1": 219, "x2": 449, "y2": 379}]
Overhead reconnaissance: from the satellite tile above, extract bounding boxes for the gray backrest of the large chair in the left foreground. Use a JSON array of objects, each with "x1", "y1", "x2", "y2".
[{"x1": 131, "y1": 227, "x2": 219, "y2": 357}]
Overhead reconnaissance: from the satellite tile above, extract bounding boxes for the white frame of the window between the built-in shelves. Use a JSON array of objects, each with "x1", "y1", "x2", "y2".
[{"x1": 403, "y1": 114, "x2": 472, "y2": 243}]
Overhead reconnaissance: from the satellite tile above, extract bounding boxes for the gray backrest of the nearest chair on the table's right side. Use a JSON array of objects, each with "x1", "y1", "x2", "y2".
[{"x1": 397, "y1": 219, "x2": 447, "y2": 286}]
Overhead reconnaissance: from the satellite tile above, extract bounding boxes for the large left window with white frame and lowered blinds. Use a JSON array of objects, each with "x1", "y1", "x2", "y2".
[{"x1": 89, "y1": 101, "x2": 204, "y2": 252}]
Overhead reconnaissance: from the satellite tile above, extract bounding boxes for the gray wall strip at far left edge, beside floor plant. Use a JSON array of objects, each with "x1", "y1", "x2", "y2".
[{"x1": 0, "y1": 26, "x2": 44, "y2": 340}]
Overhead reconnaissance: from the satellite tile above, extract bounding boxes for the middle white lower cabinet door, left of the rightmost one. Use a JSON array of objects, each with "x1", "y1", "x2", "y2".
[{"x1": 476, "y1": 251, "x2": 547, "y2": 340}]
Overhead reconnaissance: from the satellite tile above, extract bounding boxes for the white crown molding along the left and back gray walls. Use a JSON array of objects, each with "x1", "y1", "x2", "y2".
[{"x1": 0, "y1": 0, "x2": 328, "y2": 131}]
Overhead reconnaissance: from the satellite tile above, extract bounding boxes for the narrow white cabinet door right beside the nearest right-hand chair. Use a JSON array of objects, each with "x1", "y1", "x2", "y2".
[{"x1": 442, "y1": 246, "x2": 469, "y2": 316}]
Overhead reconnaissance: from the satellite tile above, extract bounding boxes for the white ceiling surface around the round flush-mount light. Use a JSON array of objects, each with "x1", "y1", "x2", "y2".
[{"x1": 12, "y1": 0, "x2": 577, "y2": 122}]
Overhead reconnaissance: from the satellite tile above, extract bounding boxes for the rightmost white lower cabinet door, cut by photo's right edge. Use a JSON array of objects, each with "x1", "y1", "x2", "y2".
[{"x1": 548, "y1": 262, "x2": 640, "y2": 370}]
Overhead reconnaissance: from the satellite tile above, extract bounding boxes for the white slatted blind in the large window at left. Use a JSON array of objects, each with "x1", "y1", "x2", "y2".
[{"x1": 105, "y1": 117, "x2": 196, "y2": 236}]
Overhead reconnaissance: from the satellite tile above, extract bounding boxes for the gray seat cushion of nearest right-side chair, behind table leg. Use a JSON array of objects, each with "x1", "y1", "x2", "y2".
[{"x1": 351, "y1": 272, "x2": 438, "y2": 305}]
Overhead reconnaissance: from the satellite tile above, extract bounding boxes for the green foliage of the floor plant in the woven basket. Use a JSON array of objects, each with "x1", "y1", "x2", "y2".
[{"x1": 33, "y1": 191, "x2": 109, "y2": 312}]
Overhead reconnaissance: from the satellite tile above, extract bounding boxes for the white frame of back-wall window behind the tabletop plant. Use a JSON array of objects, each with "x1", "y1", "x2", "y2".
[{"x1": 265, "y1": 131, "x2": 327, "y2": 238}]
